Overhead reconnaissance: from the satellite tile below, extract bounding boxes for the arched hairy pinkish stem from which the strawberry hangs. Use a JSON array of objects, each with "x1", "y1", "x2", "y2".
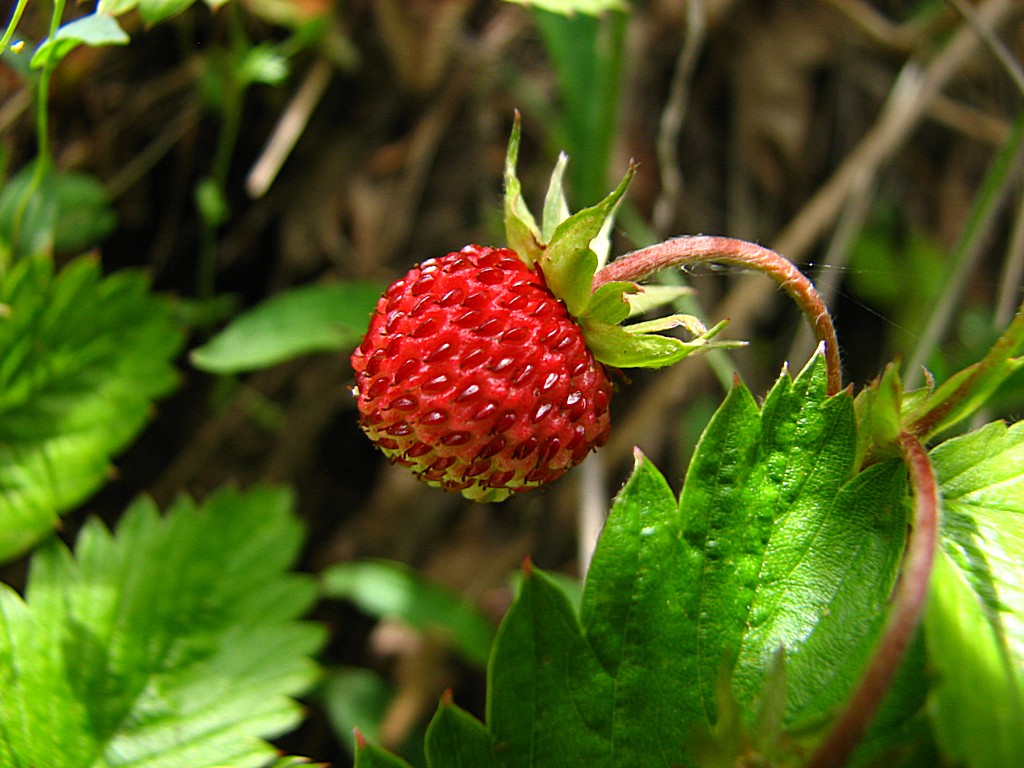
[{"x1": 594, "y1": 234, "x2": 843, "y2": 394}]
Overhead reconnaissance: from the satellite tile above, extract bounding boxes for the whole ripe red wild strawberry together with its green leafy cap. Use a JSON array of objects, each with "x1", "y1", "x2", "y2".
[{"x1": 352, "y1": 111, "x2": 721, "y2": 501}]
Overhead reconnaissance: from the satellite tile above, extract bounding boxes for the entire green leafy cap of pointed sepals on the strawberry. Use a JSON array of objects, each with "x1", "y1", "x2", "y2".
[{"x1": 504, "y1": 112, "x2": 736, "y2": 368}]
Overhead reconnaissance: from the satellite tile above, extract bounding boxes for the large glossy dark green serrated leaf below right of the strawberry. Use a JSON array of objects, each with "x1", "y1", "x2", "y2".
[{"x1": 356, "y1": 355, "x2": 907, "y2": 768}]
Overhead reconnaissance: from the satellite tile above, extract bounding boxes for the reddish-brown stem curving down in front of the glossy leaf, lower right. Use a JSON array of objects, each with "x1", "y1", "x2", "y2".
[{"x1": 806, "y1": 431, "x2": 940, "y2": 768}]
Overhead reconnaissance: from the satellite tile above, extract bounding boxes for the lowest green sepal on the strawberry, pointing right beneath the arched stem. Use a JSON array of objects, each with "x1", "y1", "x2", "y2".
[{"x1": 583, "y1": 319, "x2": 740, "y2": 368}]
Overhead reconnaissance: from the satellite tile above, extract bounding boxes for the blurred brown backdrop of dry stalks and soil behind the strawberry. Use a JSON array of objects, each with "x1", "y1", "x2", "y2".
[{"x1": 0, "y1": 0, "x2": 1024, "y2": 765}]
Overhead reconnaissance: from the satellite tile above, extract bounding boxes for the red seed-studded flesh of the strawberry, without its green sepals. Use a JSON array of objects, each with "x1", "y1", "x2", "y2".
[{"x1": 352, "y1": 246, "x2": 611, "y2": 501}]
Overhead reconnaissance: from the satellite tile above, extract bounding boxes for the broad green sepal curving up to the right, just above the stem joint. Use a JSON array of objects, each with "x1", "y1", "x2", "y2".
[{"x1": 540, "y1": 166, "x2": 636, "y2": 318}]
